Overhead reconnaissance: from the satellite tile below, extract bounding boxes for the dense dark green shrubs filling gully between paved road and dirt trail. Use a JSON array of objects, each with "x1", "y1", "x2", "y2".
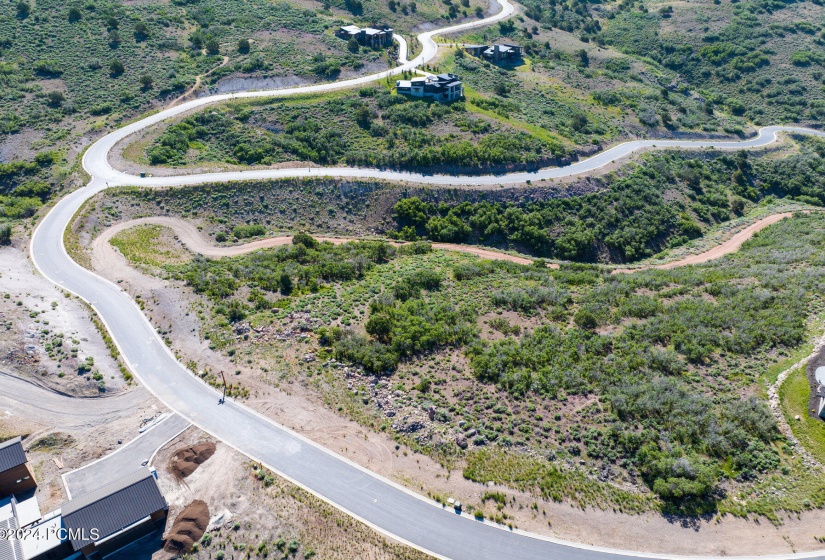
[{"x1": 394, "y1": 139, "x2": 825, "y2": 262}]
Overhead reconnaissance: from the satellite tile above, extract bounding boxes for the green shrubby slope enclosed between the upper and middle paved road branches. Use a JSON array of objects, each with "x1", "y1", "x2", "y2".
[{"x1": 146, "y1": 88, "x2": 562, "y2": 168}]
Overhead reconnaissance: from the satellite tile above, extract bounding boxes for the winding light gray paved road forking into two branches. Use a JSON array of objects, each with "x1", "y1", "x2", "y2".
[{"x1": 24, "y1": 0, "x2": 825, "y2": 560}]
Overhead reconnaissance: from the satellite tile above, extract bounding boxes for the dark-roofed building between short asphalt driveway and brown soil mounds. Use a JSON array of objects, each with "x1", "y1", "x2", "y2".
[{"x1": 61, "y1": 468, "x2": 169, "y2": 557}]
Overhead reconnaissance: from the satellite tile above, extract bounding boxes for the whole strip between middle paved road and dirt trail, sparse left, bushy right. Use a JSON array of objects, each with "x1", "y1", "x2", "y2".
[{"x1": 100, "y1": 137, "x2": 825, "y2": 263}]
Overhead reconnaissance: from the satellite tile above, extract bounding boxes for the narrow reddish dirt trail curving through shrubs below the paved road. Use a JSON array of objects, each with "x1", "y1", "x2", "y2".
[{"x1": 92, "y1": 212, "x2": 793, "y2": 274}]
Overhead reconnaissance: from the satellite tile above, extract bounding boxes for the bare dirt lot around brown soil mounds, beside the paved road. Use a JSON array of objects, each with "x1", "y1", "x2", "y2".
[{"x1": 155, "y1": 428, "x2": 426, "y2": 560}]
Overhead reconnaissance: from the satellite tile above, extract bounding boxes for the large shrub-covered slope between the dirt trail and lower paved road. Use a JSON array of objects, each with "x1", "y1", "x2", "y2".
[{"x1": 134, "y1": 214, "x2": 825, "y2": 515}]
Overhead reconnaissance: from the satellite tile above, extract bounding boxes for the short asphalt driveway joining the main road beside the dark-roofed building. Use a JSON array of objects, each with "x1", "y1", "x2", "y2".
[{"x1": 63, "y1": 414, "x2": 190, "y2": 499}]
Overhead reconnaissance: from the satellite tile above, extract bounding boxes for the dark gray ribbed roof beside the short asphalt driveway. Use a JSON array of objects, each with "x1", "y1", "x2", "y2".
[{"x1": 60, "y1": 468, "x2": 168, "y2": 550}]
